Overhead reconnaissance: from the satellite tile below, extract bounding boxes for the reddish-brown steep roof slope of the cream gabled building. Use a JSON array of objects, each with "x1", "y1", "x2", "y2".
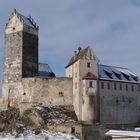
[{"x1": 66, "y1": 47, "x2": 89, "y2": 68}]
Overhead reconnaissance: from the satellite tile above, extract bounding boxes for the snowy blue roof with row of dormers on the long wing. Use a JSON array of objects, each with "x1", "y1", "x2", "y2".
[{"x1": 99, "y1": 65, "x2": 139, "y2": 83}]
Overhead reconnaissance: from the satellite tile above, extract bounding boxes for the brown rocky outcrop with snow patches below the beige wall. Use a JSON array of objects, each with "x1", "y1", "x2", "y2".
[{"x1": 0, "y1": 106, "x2": 77, "y2": 133}]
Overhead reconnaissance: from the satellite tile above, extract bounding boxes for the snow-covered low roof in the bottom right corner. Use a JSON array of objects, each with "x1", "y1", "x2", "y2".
[{"x1": 105, "y1": 130, "x2": 140, "y2": 137}]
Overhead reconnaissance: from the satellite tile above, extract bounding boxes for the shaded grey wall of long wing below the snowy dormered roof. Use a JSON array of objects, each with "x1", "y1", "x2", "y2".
[{"x1": 99, "y1": 80, "x2": 140, "y2": 124}]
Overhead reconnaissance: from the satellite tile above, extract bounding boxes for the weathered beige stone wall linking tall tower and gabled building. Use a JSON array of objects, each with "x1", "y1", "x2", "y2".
[{"x1": 3, "y1": 78, "x2": 73, "y2": 107}]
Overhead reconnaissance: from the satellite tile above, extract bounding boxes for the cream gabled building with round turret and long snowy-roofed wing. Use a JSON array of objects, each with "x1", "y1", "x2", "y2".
[{"x1": 66, "y1": 47, "x2": 140, "y2": 124}]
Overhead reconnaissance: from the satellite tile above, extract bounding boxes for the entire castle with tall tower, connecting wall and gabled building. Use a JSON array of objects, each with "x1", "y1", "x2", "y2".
[{"x1": 0, "y1": 10, "x2": 140, "y2": 124}]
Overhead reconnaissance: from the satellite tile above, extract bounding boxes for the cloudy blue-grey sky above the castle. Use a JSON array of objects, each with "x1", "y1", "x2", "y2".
[{"x1": 0, "y1": 0, "x2": 140, "y2": 81}]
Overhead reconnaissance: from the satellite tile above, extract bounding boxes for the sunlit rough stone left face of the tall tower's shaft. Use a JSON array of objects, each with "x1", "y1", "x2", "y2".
[{"x1": 3, "y1": 32, "x2": 23, "y2": 83}]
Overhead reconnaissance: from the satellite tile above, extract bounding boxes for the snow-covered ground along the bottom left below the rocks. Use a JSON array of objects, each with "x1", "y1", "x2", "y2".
[{"x1": 0, "y1": 129, "x2": 80, "y2": 140}]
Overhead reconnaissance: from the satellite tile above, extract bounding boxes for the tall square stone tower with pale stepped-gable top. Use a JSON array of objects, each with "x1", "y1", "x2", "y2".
[{"x1": 3, "y1": 10, "x2": 38, "y2": 84}]
